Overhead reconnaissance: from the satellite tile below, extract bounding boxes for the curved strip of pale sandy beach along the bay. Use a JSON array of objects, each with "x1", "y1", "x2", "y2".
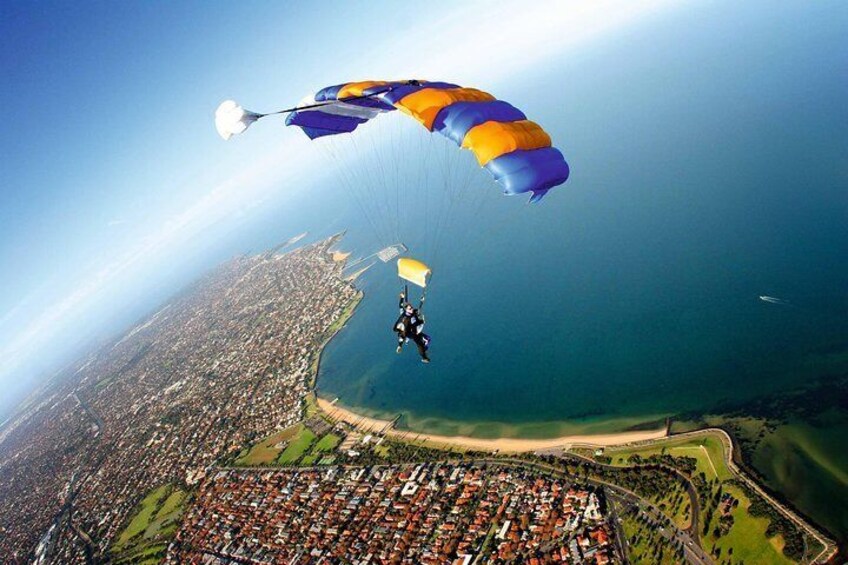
[{"x1": 318, "y1": 398, "x2": 667, "y2": 453}]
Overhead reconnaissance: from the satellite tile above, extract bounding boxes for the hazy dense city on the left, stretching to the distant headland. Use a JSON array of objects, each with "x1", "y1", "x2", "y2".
[{"x1": 0, "y1": 238, "x2": 359, "y2": 563}]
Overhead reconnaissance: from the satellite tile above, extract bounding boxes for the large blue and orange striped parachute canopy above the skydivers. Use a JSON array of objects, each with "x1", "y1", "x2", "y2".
[{"x1": 284, "y1": 80, "x2": 569, "y2": 201}]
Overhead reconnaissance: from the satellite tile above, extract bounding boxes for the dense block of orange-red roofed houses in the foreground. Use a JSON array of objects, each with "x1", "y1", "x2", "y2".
[{"x1": 167, "y1": 463, "x2": 620, "y2": 565}]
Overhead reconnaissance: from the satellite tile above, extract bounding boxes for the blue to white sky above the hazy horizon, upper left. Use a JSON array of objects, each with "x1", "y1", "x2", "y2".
[{"x1": 0, "y1": 1, "x2": 679, "y2": 415}]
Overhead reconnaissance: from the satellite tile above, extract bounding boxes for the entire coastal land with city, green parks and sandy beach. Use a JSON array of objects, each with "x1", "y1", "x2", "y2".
[{"x1": 0, "y1": 236, "x2": 835, "y2": 565}]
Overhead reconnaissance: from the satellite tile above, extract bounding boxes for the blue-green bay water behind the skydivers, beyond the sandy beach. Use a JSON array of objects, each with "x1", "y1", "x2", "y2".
[{"x1": 319, "y1": 4, "x2": 848, "y2": 432}]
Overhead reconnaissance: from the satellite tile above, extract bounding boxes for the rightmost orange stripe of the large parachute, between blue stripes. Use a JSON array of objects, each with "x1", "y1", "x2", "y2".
[{"x1": 462, "y1": 120, "x2": 551, "y2": 167}]
